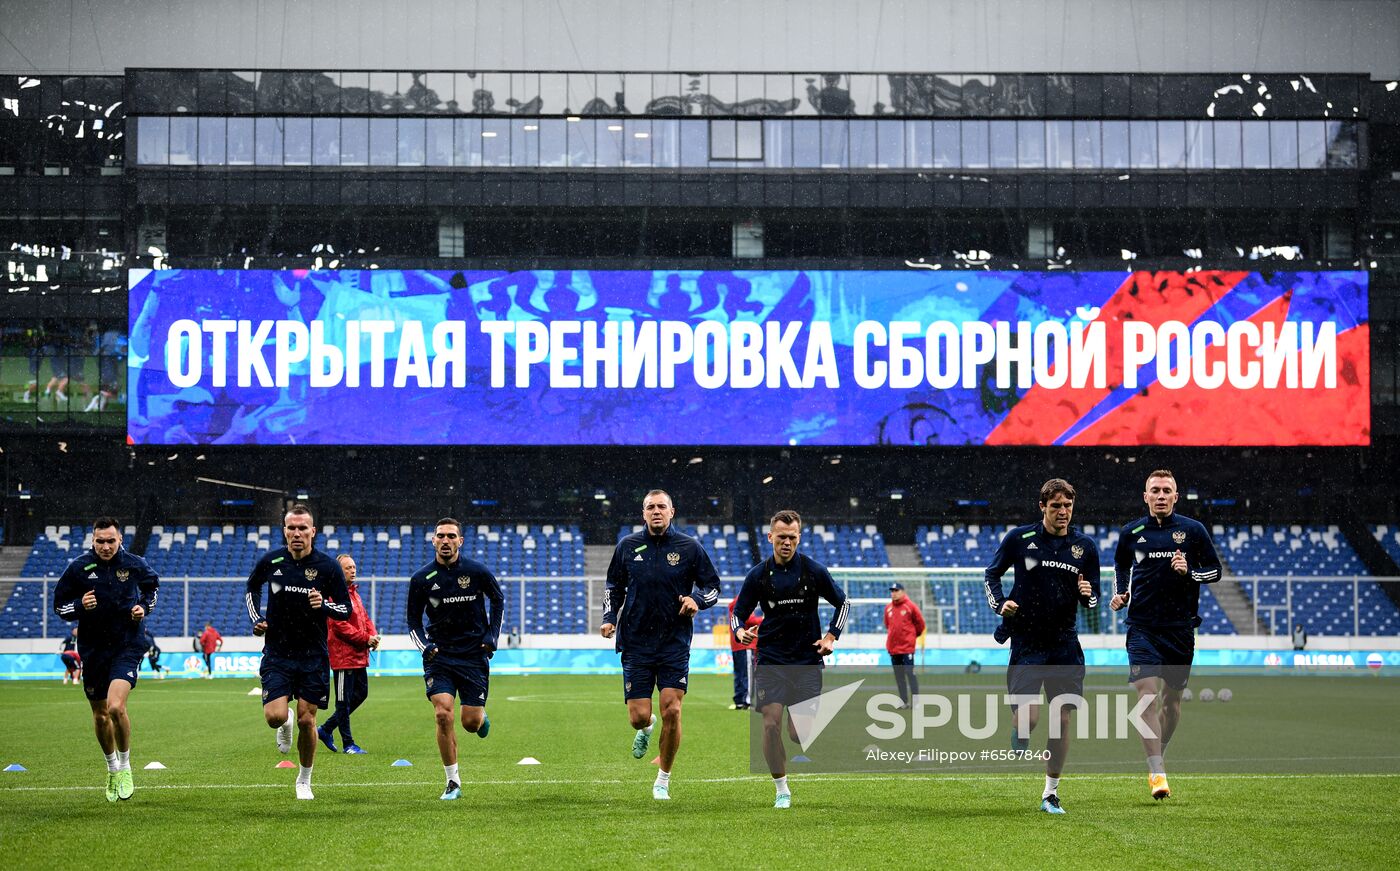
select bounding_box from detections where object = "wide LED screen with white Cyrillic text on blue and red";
[127,269,1371,445]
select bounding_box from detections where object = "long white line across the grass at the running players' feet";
[0,772,1400,793]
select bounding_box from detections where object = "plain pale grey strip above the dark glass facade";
[0,0,1400,78]
